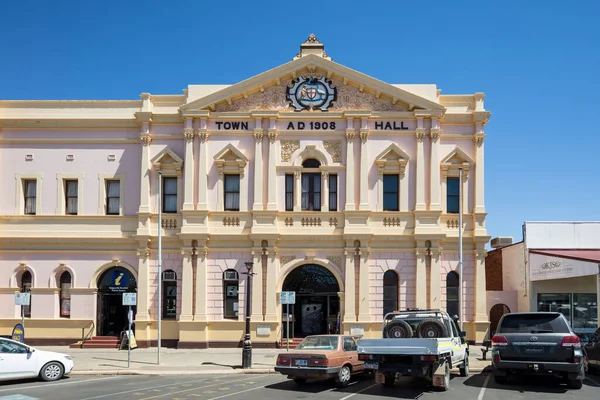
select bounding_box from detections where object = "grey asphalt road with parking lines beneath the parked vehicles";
[0,373,600,400]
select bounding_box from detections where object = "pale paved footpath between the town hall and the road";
[31,346,489,375]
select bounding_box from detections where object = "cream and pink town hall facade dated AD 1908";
[0,35,490,347]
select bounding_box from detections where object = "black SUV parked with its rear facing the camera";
[492,312,585,389]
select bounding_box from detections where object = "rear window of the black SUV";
[496,314,570,333]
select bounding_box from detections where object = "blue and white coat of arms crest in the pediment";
[286,76,337,111]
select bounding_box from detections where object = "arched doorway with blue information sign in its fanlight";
[96,267,137,336]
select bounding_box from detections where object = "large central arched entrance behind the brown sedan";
[282,264,341,337]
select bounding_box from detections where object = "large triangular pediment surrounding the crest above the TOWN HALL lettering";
[181,54,444,115]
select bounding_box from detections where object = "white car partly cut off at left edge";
[0,338,73,381]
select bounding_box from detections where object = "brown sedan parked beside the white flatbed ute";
[275,335,365,387]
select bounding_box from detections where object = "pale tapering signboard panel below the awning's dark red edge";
[529,253,600,281]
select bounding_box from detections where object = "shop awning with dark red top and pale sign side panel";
[529,250,600,281]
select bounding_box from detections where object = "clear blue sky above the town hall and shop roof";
[0,0,600,244]
